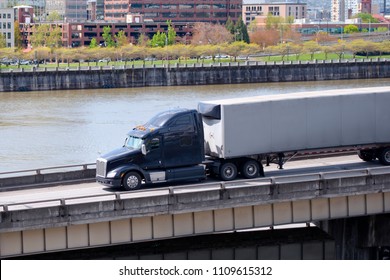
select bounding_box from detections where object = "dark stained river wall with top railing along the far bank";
[0,59,390,92]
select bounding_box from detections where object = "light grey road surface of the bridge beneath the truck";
[0,155,382,206]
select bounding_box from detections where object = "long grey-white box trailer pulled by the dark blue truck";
[198,87,390,179]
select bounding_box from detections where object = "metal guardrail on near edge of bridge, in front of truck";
[0,166,390,212]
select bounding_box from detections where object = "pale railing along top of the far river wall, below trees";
[0,57,390,73]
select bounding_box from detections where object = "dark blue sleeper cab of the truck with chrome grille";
[96,109,206,190]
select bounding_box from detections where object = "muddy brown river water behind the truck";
[0,79,390,172]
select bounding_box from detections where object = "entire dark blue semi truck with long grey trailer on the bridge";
[96,87,390,190]
